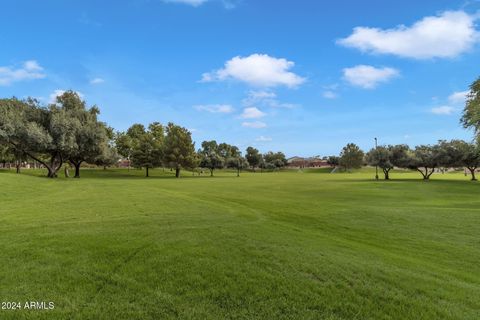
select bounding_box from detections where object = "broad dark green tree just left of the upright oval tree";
[127,122,165,177]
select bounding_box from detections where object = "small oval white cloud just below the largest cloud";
[343,65,399,89]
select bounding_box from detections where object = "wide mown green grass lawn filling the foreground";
[0,170,480,320]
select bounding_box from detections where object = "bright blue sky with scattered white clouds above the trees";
[0,0,480,156]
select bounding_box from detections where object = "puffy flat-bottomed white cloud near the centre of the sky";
[202,54,305,88]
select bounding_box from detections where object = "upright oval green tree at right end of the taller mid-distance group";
[163,122,196,178]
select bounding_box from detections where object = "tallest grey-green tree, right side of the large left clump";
[56,91,112,178]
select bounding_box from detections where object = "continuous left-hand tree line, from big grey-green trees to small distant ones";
[0,91,287,178]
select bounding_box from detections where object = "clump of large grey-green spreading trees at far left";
[0,91,116,178]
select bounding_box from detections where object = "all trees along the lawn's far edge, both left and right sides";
[0,78,480,180]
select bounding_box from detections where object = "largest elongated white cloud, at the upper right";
[337,11,480,59]
